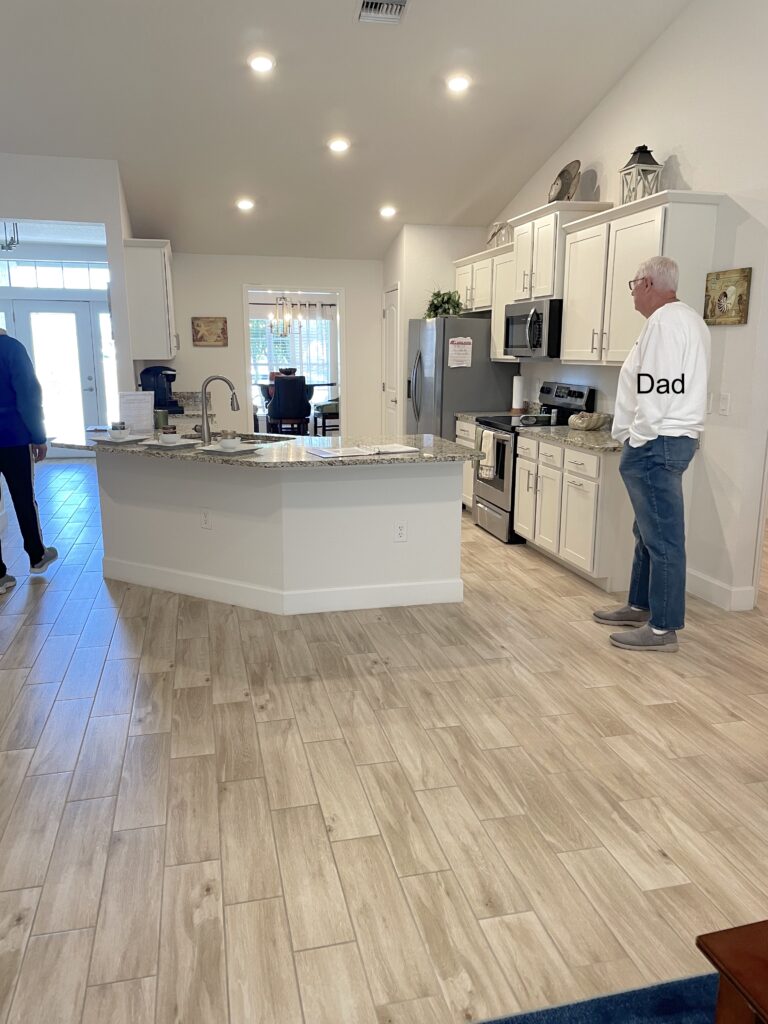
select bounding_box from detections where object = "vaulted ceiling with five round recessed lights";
[0,0,687,258]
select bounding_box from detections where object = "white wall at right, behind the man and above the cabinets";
[495,0,768,605]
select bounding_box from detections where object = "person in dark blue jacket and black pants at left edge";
[0,330,58,594]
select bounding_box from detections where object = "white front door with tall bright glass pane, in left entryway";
[13,300,102,457]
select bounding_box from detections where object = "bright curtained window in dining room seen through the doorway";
[250,302,339,404]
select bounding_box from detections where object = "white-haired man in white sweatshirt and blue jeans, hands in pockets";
[594,256,710,653]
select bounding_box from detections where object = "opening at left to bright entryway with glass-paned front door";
[0,221,119,458]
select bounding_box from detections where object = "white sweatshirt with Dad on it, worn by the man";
[611,301,710,447]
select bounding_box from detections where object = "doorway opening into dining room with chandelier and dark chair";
[246,288,342,434]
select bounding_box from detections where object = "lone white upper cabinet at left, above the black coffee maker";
[124,239,178,359]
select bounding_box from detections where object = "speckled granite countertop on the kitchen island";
[52,434,482,469]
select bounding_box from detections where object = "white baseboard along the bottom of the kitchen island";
[101,558,464,615]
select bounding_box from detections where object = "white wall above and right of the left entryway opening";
[0,153,134,389]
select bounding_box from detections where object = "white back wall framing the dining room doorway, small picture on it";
[171,253,382,435]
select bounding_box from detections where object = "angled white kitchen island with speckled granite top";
[54,434,479,614]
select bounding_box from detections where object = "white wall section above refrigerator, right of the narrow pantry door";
[384,224,487,430]
